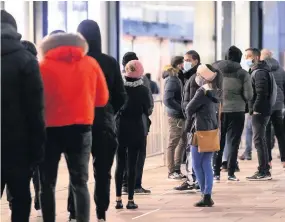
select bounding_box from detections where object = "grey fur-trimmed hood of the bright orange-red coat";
[40,33,88,62]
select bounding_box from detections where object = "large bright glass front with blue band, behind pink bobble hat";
[120,1,195,82]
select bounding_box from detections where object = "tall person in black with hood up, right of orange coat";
[76,20,127,220]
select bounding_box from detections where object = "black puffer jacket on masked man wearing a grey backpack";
[249,61,272,116]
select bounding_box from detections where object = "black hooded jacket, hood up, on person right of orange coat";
[77,20,127,131]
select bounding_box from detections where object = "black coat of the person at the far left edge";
[1,22,45,169]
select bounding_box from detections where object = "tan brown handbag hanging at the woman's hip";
[195,129,220,153]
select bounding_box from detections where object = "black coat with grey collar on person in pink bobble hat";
[118,77,151,146]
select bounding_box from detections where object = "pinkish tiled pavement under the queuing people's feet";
[1,148,285,222]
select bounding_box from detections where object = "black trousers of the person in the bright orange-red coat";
[40,125,92,222]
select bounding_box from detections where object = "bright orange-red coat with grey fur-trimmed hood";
[40,33,109,127]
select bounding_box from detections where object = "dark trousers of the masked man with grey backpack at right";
[252,114,270,174]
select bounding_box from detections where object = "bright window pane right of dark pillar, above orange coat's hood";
[48,1,67,33]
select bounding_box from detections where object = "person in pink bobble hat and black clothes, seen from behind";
[115,60,151,209]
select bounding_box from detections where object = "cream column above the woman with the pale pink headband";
[193,1,216,63]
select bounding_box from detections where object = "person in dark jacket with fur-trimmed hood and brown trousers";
[163,56,187,180]
